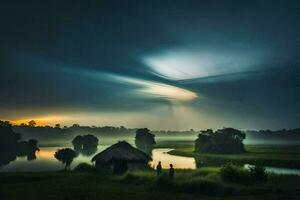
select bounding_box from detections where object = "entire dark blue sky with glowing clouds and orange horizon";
[0,0,300,129]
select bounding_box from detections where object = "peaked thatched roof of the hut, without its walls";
[92,141,152,163]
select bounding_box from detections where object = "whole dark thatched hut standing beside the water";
[92,141,152,173]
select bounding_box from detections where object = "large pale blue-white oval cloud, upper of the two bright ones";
[142,48,266,80]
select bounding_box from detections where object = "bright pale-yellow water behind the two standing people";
[150,148,196,169]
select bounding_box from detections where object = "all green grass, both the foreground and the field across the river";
[0,141,300,200]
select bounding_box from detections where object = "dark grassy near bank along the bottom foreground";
[0,168,300,200]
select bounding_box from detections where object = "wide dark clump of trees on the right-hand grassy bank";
[195,128,245,153]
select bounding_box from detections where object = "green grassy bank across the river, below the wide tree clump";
[168,144,300,168]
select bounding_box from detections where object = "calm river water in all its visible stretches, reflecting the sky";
[0,145,300,175]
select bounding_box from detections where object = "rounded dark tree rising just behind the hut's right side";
[135,128,156,154]
